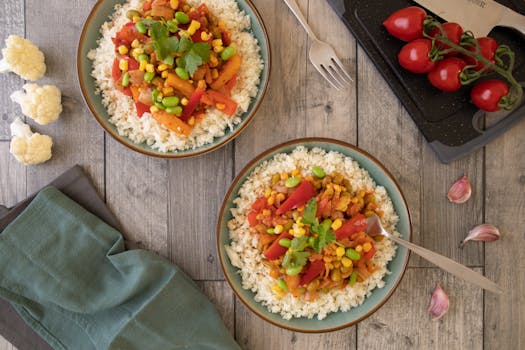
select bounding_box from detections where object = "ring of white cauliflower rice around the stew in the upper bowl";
[88,0,264,152]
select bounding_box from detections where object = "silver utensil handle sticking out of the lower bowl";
[388,234,503,294]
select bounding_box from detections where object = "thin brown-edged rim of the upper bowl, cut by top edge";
[76,0,272,159]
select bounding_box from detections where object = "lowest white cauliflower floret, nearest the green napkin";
[9,118,53,165]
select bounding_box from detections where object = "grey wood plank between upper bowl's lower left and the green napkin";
[106,136,170,257]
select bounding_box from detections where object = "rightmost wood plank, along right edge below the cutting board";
[484,122,525,349]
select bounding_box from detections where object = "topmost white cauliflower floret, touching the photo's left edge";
[0,35,46,81]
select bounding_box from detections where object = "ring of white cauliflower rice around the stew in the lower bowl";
[225,146,399,320]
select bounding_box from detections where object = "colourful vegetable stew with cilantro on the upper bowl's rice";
[112,0,242,136]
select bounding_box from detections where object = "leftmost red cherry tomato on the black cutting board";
[383,6,427,41]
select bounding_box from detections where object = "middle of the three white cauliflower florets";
[11,84,62,125]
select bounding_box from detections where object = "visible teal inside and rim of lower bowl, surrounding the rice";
[217,138,412,333]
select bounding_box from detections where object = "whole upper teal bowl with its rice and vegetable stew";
[77,0,270,158]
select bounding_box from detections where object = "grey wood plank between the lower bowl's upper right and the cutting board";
[357,46,424,265]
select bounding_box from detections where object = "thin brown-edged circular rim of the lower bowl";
[216,137,412,333]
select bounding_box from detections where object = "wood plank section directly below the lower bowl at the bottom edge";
[235,299,356,350]
